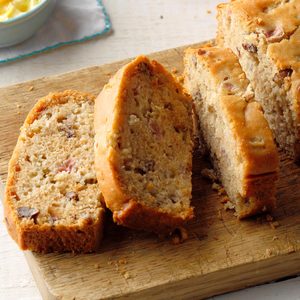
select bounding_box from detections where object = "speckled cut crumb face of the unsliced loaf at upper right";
[218,1,300,157]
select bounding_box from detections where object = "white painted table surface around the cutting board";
[0,0,300,300]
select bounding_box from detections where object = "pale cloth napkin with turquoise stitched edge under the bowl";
[0,0,111,64]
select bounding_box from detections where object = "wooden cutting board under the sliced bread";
[0,42,300,300]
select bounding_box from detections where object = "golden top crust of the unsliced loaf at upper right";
[217,0,300,69]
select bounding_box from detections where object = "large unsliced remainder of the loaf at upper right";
[217,0,300,160]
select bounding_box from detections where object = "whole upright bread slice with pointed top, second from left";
[95,56,193,234]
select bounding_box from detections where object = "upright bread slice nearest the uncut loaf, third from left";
[184,45,278,218]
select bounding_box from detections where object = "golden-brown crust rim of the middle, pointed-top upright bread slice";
[94,56,193,233]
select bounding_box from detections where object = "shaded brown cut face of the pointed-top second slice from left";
[113,62,192,216]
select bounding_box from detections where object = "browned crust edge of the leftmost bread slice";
[4,91,104,253]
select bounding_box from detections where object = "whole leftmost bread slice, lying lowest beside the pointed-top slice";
[4,91,104,252]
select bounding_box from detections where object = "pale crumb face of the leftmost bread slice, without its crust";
[14,96,101,225]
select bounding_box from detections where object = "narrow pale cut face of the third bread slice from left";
[185,49,256,212]
